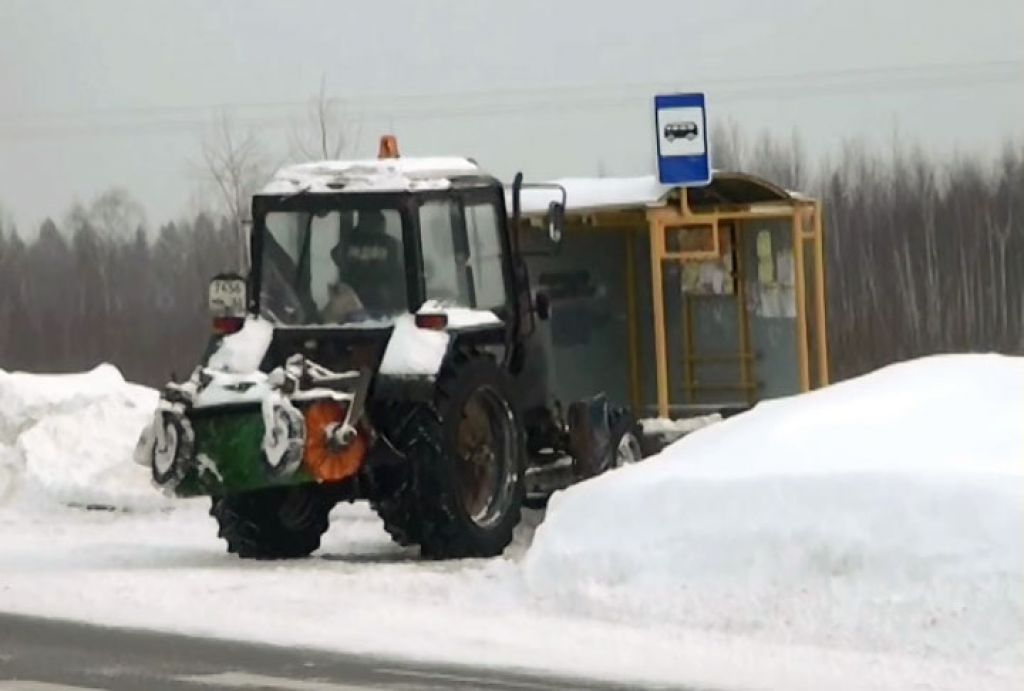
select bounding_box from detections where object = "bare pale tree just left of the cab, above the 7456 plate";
[203,113,268,271]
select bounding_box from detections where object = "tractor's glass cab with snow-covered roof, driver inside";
[251,159,517,327]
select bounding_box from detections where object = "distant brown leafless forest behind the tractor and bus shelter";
[0,127,1024,385]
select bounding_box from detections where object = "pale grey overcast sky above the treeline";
[0,0,1024,232]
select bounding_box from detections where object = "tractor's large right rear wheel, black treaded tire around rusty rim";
[374,353,525,559]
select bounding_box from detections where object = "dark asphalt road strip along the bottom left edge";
[0,613,663,691]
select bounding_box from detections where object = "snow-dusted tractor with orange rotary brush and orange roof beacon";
[136,137,642,559]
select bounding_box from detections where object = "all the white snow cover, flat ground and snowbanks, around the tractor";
[0,355,1024,689]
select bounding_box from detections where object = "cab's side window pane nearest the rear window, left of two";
[420,201,473,307]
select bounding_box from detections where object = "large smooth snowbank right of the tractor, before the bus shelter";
[523,355,1024,670]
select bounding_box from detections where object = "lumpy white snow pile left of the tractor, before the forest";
[0,364,165,509]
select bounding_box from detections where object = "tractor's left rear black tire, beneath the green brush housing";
[210,484,333,559]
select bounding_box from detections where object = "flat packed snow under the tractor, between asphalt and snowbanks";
[0,501,1019,691]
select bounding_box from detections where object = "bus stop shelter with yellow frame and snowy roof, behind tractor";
[520,171,828,418]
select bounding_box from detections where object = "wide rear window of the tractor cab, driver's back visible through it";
[260,209,409,325]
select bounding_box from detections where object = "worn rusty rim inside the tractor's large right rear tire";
[456,388,519,528]
